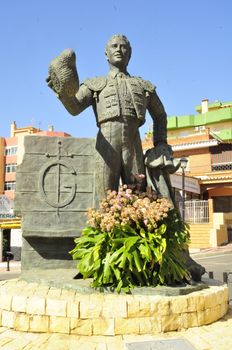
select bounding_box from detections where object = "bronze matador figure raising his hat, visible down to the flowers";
[47,35,171,204]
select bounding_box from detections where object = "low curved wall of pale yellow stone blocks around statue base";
[0,280,228,336]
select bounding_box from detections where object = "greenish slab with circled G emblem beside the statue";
[14,135,96,270]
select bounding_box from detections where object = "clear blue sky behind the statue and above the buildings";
[0,0,232,137]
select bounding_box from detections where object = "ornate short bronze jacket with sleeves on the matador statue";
[57,71,167,144]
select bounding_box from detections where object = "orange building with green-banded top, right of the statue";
[143,100,232,248]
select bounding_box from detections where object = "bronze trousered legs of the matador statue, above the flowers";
[96,118,145,200]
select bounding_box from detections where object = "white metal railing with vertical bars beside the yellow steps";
[179,200,209,224]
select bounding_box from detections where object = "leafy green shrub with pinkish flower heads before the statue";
[70,185,189,292]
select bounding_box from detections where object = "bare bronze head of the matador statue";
[105,34,132,69]
